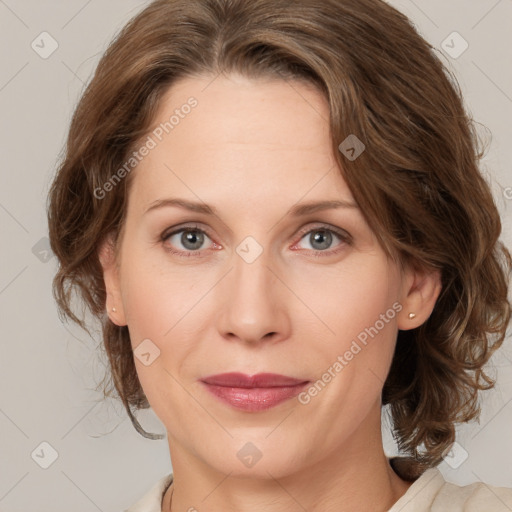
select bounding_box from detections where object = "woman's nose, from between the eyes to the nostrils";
[217,246,291,344]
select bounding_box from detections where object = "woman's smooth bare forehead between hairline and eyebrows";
[126,75,351,212]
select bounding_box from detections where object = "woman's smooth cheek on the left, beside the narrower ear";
[122,257,200,418]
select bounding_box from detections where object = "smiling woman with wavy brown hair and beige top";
[48,0,512,512]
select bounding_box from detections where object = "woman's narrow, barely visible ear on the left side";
[98,234,127,326]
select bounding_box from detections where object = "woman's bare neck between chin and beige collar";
[162,411,411,512]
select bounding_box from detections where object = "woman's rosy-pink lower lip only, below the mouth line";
[203,382,309,412]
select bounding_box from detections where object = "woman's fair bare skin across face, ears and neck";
[100,75,441,512]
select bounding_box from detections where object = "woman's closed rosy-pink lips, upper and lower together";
[201,373,310,412]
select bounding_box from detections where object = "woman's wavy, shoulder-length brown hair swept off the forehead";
[48,0,512,473]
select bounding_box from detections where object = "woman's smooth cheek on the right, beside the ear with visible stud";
[292,254,401,408]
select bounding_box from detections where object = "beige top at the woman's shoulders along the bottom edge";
[124,468,512,512]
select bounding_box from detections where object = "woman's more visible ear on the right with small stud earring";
[398,266,442,331]
